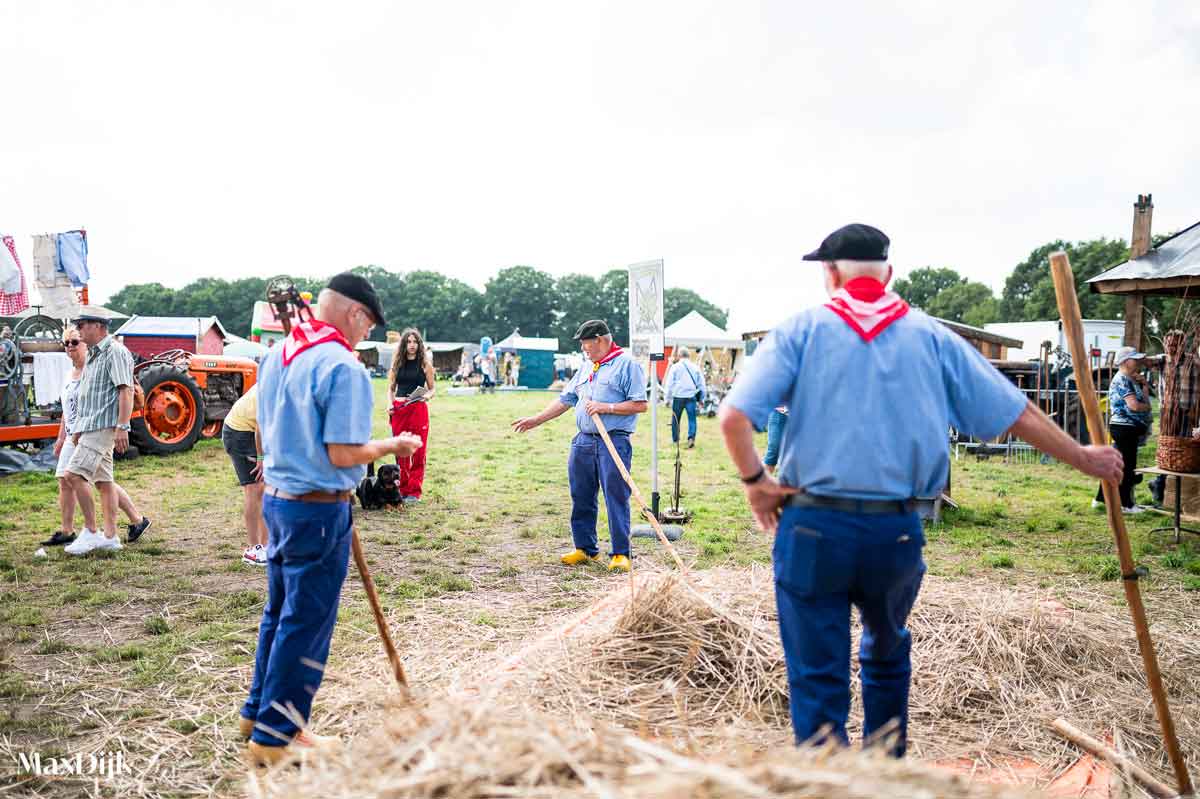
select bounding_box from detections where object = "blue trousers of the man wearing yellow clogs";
[566,433,634,555]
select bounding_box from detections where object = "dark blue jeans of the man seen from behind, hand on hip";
[774,507,925,757]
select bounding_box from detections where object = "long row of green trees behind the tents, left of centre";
[106,265,728,350]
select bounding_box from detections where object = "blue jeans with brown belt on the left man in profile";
[241,494,352,746]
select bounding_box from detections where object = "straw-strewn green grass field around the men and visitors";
[0,383,1200,795]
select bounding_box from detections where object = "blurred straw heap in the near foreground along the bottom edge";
[260,699,1032,799]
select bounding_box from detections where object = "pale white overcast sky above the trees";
[0,0,1200,331]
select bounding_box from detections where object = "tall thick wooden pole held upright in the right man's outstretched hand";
[1050,252,1192,797]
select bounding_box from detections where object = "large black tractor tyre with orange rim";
[131,364,204,455]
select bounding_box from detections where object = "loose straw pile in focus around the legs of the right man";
[526,569,1200,775]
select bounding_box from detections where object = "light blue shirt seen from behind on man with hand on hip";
[725,306,1027,499]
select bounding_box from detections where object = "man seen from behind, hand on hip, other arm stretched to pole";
[720,224,1121,757]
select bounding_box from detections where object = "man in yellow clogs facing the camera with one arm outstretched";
[512,319,647,571]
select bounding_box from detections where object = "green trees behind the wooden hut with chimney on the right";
[894,234,1178,340]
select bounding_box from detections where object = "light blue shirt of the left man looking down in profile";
[258,342,374,495]
